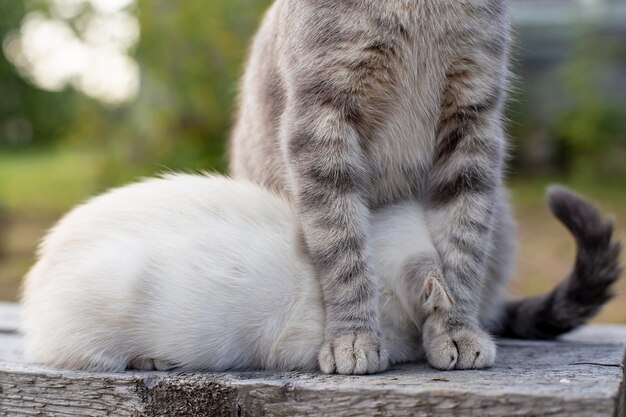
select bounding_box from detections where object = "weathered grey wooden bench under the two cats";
[0,304,626,417]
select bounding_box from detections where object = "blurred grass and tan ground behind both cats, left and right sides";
[0,150,626,324]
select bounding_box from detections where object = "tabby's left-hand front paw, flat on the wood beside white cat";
[319,332,389,375]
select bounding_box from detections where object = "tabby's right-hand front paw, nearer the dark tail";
[424,318,496,371]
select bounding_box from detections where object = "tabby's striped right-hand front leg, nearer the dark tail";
[425,44,506,369]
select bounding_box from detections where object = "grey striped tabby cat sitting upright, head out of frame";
[231,0,619,374]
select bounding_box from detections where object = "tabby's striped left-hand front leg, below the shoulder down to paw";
[289,109,388,374]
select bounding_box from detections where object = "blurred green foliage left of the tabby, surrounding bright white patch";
[0,0,271,185]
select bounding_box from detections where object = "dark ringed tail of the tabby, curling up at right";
[499,186,622,339]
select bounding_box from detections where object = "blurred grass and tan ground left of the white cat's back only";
[0,150,103,301]
